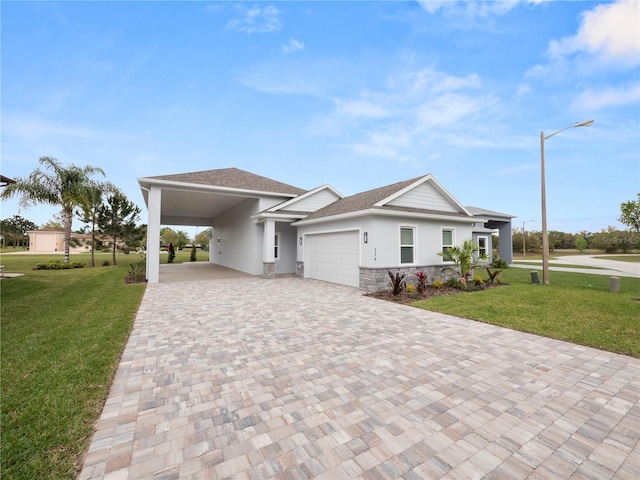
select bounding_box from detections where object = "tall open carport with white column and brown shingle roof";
[138,168,304,283]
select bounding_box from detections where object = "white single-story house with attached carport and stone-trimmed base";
[138,168,513,291]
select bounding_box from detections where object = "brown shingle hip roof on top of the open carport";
[146,168,306,195]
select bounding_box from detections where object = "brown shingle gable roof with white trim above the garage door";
[297,174,471,224]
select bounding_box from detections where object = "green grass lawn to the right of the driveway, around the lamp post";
[410,268,640,357]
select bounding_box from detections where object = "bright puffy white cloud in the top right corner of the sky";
[549,0,640,66]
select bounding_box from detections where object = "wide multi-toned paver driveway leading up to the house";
[80,278,640,480]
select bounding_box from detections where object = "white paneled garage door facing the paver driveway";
[304,231,360,287]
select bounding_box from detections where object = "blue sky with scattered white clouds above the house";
[0,1,640,237]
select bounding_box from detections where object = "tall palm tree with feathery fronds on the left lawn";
[0,157,104,263]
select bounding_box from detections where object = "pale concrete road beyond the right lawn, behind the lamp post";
[513,255,640,278]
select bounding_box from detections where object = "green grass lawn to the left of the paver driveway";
[0,254,145,479]
